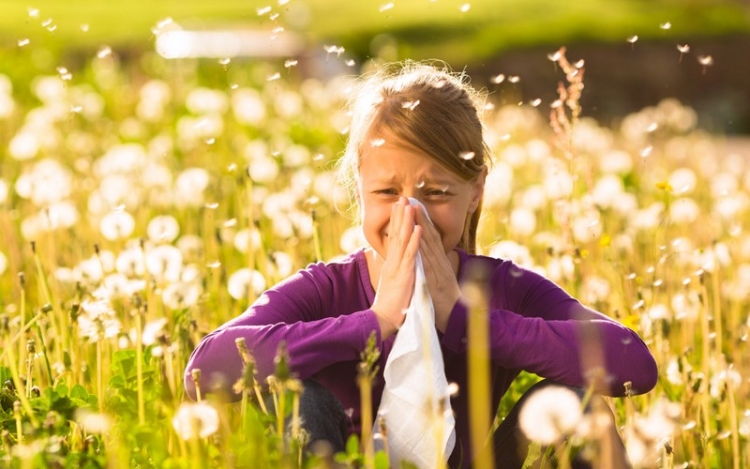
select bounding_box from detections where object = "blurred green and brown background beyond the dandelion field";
[0,0,750,133]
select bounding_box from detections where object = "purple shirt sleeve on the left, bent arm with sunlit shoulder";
[184,265,380,398]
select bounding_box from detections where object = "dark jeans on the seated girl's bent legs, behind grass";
[284,379,630,469]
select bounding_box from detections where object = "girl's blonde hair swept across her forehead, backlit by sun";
[338,61,489,253]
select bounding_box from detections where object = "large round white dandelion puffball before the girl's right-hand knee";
[518,386,583,445]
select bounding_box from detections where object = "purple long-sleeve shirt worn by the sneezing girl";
[185,250,657,465]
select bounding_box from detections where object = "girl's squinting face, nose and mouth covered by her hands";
[359,133,484,258]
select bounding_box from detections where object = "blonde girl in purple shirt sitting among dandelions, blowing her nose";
[185,63,657,467]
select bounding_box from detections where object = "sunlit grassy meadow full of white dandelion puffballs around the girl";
[0,0,750,469]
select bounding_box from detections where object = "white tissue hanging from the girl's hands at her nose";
[373,198,456,469]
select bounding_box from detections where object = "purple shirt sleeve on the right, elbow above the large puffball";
[443,261,657,396]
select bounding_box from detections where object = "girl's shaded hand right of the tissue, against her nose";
[416,209,461,332]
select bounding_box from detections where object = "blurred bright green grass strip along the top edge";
[0,0,750,61]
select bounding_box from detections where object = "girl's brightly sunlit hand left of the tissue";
[371,197,422,340]
